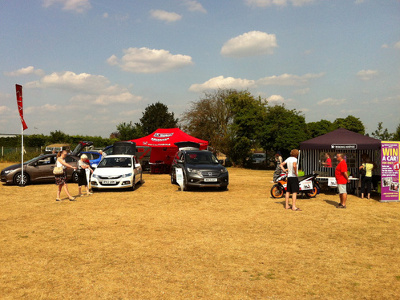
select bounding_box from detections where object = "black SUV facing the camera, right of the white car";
[171,150,229,191]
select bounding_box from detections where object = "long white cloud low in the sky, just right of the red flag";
[25,71,142,105]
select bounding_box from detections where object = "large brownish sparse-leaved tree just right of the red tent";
[181,89,237,154]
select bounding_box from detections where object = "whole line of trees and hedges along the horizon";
[0,89,400,165]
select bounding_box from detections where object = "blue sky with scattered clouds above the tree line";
[0,0,400,137]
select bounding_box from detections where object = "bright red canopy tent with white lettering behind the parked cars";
[131,128,208,172]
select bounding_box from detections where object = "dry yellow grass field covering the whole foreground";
[0,164,400,299]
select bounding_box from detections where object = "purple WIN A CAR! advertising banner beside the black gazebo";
[381,142,400,202]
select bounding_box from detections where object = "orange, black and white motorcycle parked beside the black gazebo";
[271,173,321,198]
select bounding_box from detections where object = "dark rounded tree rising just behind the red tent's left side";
[140,102,178,135]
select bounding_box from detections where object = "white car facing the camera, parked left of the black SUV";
[90,155,143,190]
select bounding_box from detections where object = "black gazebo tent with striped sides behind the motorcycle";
[300,128,381,177]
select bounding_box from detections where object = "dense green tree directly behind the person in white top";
[261,104,308,156]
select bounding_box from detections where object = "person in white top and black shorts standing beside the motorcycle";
[280,149,301,211]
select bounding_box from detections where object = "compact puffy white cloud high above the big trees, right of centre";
[221,31,278,57]
